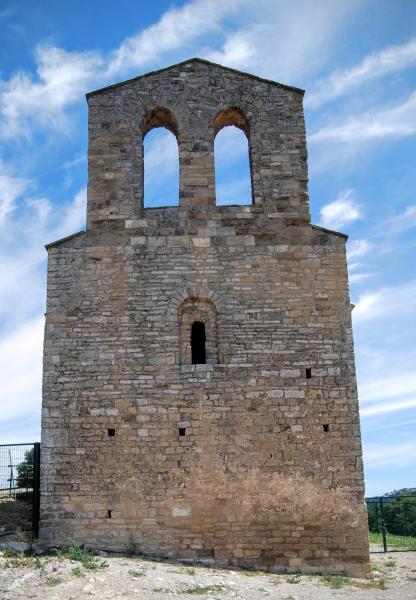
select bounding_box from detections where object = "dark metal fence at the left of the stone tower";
[0,443,40,538]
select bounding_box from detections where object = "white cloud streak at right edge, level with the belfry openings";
[309,92,416,148]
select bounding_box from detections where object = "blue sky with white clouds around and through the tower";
[0,0,416,495]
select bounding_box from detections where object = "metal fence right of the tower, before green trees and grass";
[366,490,416,552]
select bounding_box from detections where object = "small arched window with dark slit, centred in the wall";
[179,298,218,365]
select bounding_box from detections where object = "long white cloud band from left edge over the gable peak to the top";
[0,0,360,138]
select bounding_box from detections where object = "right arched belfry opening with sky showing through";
[213,108,253,205]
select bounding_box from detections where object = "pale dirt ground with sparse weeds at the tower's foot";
[0,552,416,600]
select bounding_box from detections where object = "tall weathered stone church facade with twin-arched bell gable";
[41,59,369,575]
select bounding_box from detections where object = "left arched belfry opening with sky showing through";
[143,107,179,208]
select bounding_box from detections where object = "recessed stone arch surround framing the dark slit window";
[178,296,218,365]
